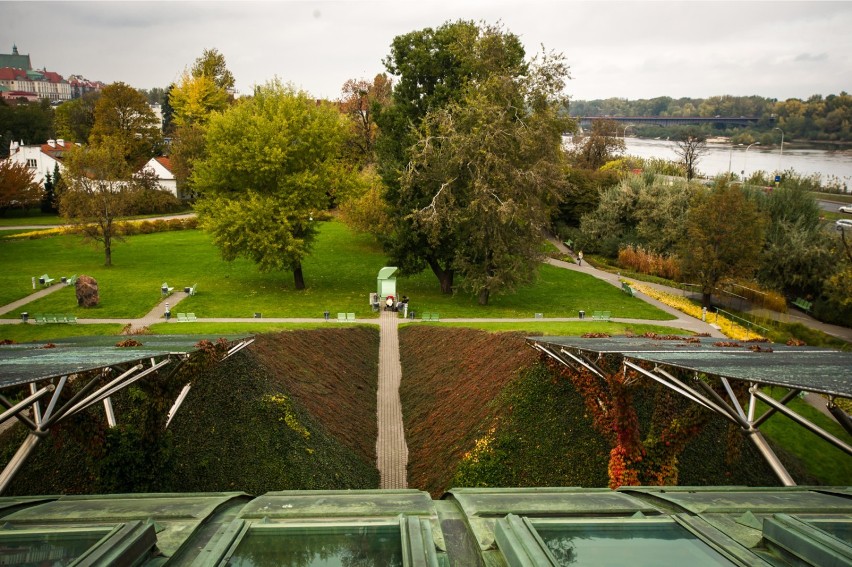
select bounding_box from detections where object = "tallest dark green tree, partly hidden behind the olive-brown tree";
[376,21,527,293]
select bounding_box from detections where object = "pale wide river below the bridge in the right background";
[568,137,852,191]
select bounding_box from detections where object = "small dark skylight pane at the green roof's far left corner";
[0,531,107,567]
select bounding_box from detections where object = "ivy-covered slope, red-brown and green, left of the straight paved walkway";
[3,328,379,495]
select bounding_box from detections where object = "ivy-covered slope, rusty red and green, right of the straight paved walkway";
[400,326,792,496]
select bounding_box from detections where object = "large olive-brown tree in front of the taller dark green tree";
[401,54,567,305]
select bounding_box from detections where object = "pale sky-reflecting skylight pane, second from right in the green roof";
[534,522,731,567]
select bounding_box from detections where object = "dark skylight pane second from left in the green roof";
[228,525,402,567]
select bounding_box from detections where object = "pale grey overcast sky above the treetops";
[0,0,852,100]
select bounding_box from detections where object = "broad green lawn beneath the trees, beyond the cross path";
[0,222,672,320]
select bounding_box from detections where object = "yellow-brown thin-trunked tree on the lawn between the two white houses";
[59,138,134,266]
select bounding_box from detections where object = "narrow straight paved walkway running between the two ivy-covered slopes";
[376,311,408,488]
